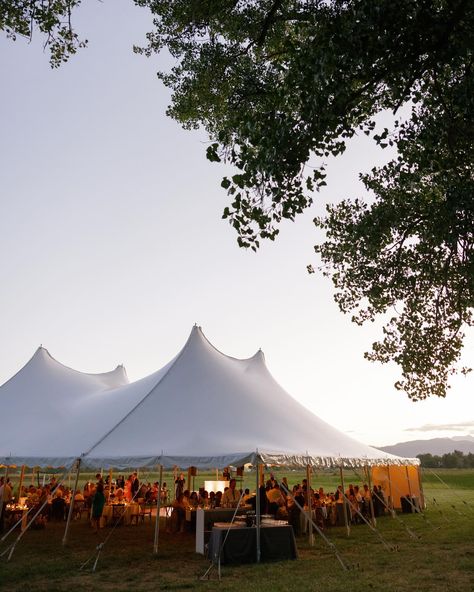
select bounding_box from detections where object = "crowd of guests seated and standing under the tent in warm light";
[0,471,387,533]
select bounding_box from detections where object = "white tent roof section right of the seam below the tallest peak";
[85,326,417,468]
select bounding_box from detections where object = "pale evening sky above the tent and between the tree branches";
[0,0,474,445]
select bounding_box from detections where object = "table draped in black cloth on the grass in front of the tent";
[209,525,298,563]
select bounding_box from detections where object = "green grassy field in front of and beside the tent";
[0,470,474,592]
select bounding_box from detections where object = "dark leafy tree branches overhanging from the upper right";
[0,0,474,400]
